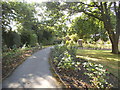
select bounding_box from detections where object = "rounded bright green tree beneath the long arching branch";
[69,13,108,41]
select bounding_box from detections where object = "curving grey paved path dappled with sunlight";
[2,47,60,88]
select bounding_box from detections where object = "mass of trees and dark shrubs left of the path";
[1,1,54,48]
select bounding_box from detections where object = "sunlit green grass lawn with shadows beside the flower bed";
[77,49,120,79]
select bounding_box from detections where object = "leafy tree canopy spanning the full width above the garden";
[2,1,120,53]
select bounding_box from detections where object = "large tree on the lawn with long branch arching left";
[45,1,120,54]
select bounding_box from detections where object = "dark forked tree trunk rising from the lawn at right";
[100,2,120,54]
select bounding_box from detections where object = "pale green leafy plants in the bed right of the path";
[51,41,115,88]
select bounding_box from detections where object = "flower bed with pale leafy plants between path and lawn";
[51,44,118,88]
